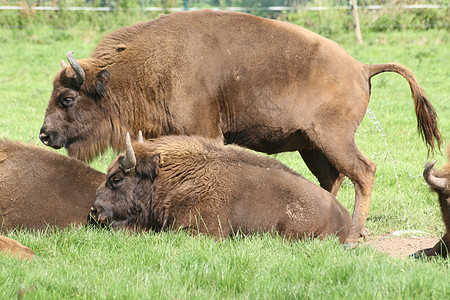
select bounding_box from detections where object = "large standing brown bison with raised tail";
[40,10,441,240]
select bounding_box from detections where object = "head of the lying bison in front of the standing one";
[91,134,159,229]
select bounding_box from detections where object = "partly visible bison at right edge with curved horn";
[414,144,450,258]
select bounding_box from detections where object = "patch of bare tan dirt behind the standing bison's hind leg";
[363,234,439,258]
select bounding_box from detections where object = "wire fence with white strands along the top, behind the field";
[0,0,450,12]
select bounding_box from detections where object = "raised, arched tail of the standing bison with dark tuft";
[367,63,442,154]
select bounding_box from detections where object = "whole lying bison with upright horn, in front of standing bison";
[92,135,350,242]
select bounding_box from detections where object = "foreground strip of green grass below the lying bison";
[0,228,449,299]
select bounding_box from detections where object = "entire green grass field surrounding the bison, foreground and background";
[0,18,450,299]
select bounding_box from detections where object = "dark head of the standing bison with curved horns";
[39,51,112,160]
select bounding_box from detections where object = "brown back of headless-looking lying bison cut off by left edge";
[0,140,105,231]
